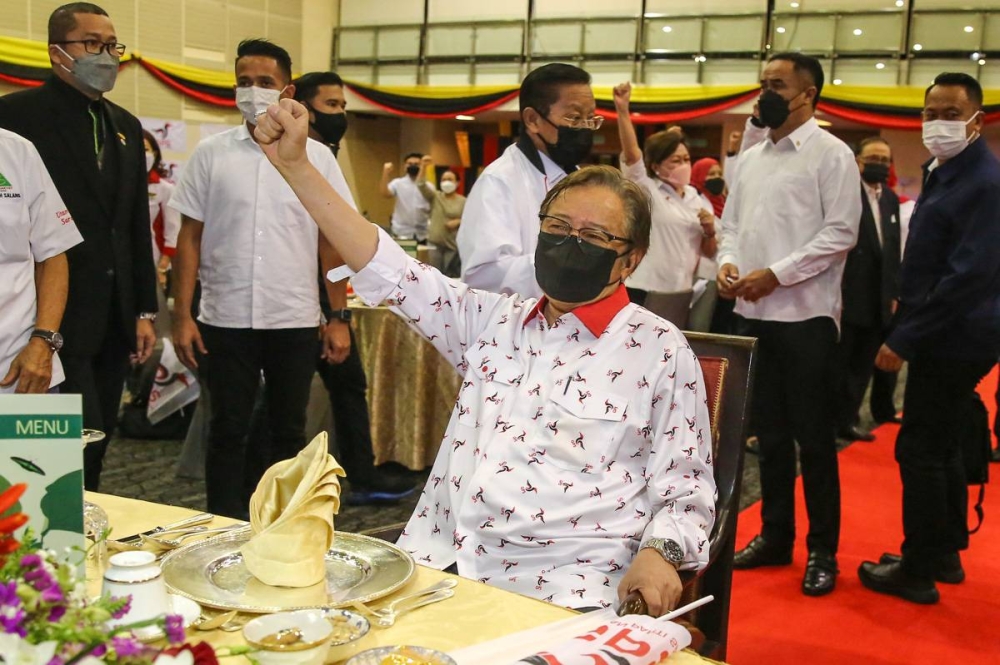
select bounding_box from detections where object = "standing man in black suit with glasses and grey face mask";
[0,2,157,490]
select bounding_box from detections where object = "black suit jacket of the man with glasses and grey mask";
[0,76,157,356]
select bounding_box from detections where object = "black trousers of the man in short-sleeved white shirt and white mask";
[198,323,319,519]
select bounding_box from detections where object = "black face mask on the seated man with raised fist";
[535,231,628,303]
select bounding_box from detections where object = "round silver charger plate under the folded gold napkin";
[160,528,413,614]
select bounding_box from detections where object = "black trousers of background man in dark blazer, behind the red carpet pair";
[835,323,883,429]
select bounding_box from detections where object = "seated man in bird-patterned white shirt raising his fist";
[257,100,715,615]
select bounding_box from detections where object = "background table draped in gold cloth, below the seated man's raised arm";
[351,306,462,470]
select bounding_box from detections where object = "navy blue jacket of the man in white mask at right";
[886,138,1000,362]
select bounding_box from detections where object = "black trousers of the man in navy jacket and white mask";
[896,355,996,577]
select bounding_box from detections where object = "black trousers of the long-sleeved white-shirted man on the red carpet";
[738,317,840,554]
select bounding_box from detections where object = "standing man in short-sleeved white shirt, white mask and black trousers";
[170,39,353,518]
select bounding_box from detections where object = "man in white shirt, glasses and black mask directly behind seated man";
[458,63,604,298]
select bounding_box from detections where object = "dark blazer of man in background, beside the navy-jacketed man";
[841,184,900,326]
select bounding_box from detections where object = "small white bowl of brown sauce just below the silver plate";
[243,610,333,665]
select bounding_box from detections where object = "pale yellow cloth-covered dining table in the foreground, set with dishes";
[87,492,714,665]
